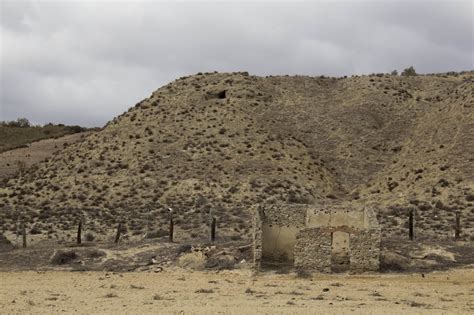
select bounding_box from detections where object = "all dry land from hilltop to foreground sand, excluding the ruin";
[0,71,474,314]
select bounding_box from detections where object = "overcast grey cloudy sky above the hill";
[0,0,474,127]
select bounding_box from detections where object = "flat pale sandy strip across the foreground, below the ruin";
[0,268,474,314]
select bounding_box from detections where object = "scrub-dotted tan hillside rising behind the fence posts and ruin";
[0,72,474,238]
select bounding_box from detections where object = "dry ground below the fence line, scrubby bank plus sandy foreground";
[0,238,474,314]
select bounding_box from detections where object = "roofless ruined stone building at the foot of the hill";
[253,204,380,272]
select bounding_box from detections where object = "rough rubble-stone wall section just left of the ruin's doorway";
[295,228,332,272]
